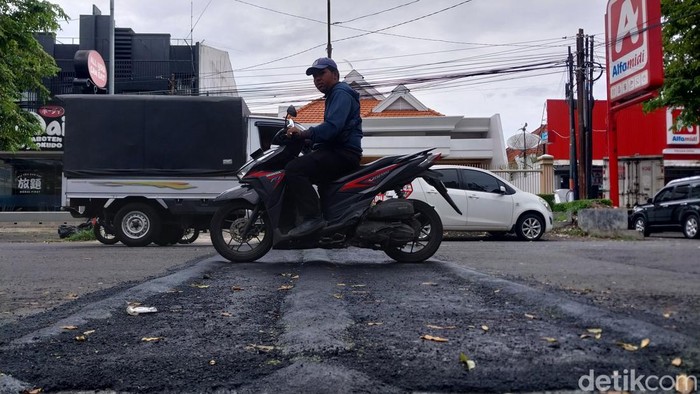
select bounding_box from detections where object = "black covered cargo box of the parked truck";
[58,95,250,178]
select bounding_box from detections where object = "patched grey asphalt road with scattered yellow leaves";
[0,232,700,392]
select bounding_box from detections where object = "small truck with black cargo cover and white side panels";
[58,95,284,246]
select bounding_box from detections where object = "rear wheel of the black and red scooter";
[384,200,442,263]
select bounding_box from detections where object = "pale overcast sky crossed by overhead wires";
[52,0,607,139]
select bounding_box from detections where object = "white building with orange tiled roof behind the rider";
[296,70,508,168]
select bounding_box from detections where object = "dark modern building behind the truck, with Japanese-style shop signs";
[0,6,238,211]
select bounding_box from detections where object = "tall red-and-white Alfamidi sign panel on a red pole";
[605,0,664,103]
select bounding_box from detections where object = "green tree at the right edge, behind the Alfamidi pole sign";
[644,0,700,128]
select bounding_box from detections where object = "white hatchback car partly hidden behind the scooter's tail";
[406,165,554,241]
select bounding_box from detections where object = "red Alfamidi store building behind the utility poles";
[546,100,700,207]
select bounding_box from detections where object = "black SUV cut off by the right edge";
[630,176,700,238]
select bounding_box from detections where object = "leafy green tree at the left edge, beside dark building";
[0,0,68,151]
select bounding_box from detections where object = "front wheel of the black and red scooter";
[209,201,272,263]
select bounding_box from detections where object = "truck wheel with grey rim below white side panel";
[114,203,161,246]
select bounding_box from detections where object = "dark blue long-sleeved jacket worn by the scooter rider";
[309,82,362,155]
